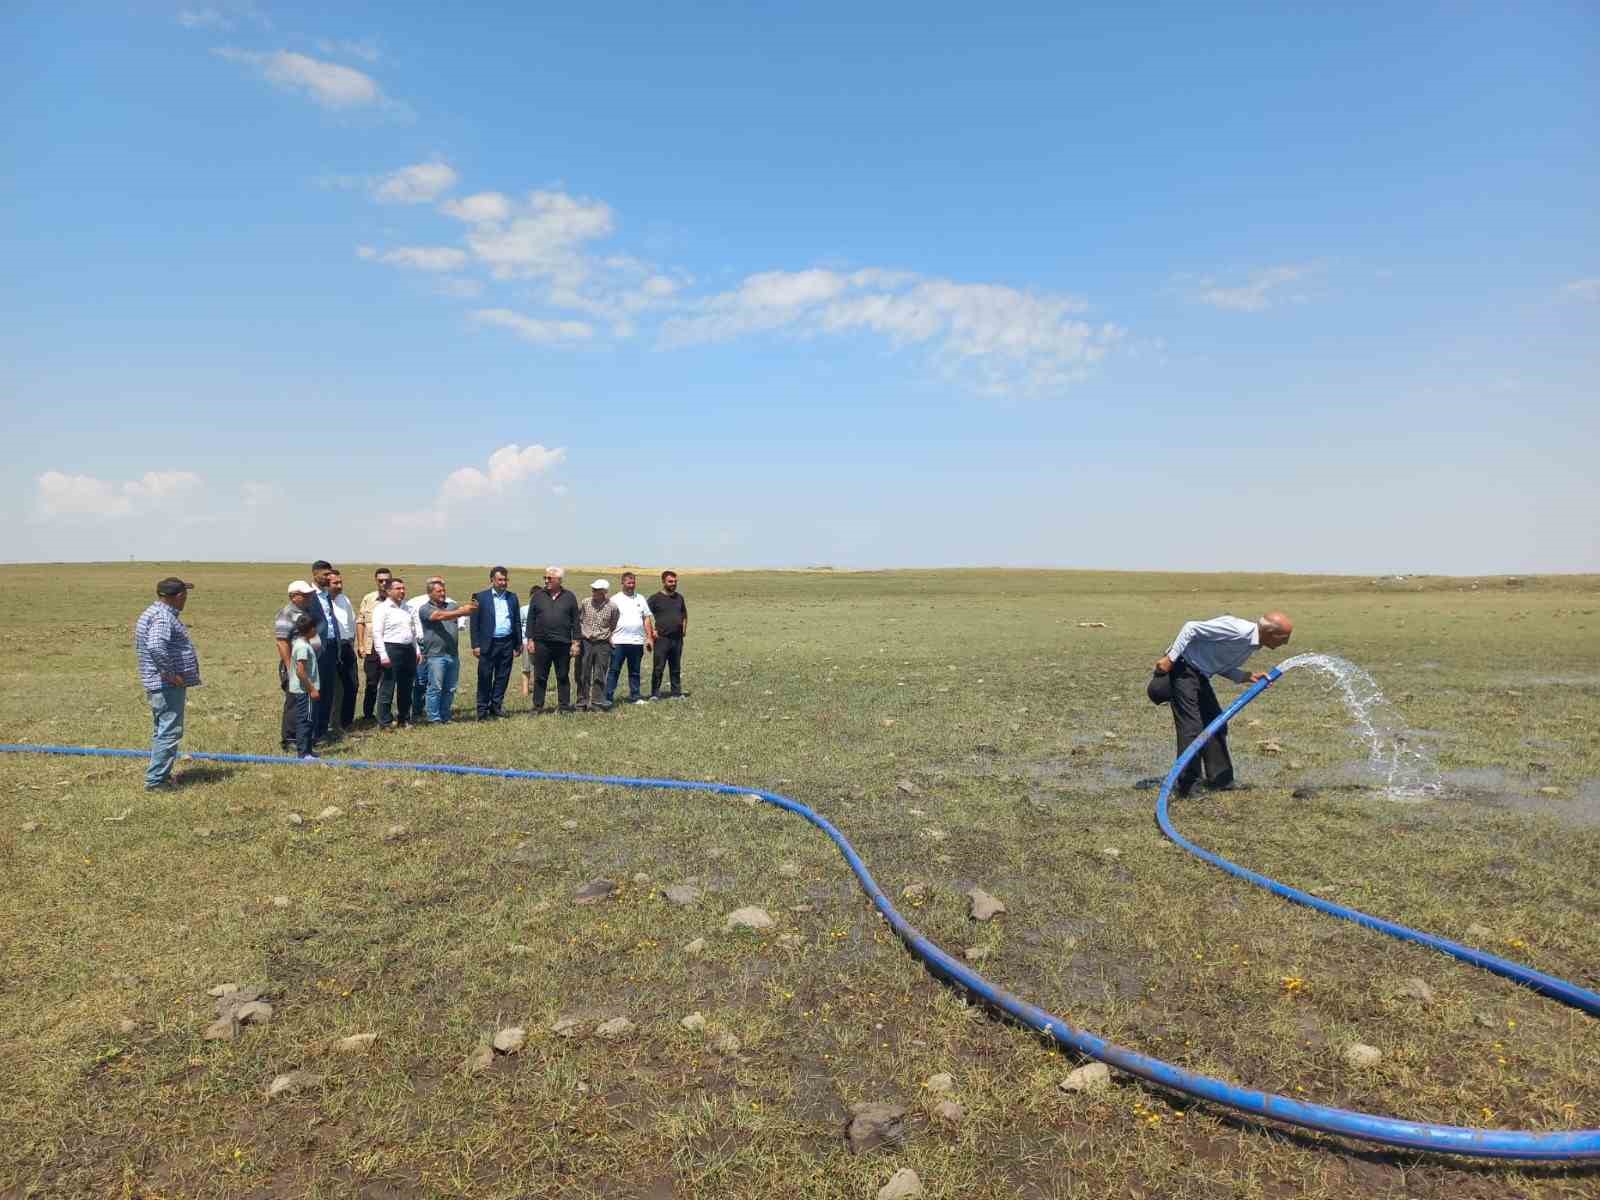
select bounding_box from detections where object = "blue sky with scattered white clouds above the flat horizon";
[0,0,1600,573]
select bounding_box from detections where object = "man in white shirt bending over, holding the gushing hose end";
[1146,613,1294,797]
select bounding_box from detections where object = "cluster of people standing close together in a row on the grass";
[274,560,688,757]
